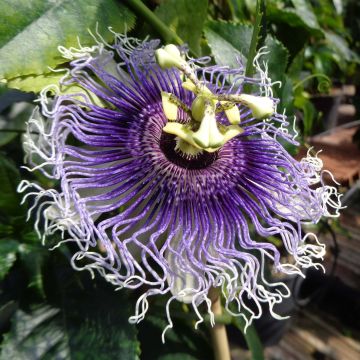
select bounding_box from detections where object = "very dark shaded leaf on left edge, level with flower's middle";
[0,154,23,215]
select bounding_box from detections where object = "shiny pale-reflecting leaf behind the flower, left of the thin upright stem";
[204,21,252,68]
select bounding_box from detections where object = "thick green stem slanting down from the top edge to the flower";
[125,0,184,45]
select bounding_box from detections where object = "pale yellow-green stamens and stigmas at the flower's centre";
[155,44,275,155]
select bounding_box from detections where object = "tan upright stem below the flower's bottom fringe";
[209,288,231,360]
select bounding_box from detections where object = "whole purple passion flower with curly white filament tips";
[19,34,340,336]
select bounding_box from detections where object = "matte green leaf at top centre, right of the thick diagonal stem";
[155,0,208,54]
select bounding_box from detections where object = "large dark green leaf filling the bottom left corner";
[0,299,138,360]
